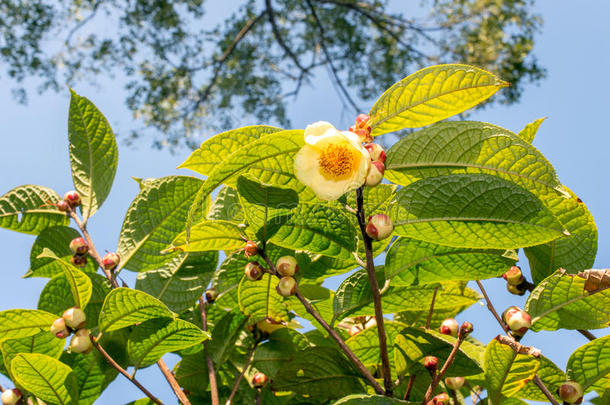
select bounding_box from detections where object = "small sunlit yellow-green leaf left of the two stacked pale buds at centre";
[238,273,289,324]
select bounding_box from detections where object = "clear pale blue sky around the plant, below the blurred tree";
[0,0,610,404]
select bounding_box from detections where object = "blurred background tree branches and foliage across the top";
[0,0,545,146]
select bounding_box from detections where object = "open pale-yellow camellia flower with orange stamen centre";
[294,121,371,201]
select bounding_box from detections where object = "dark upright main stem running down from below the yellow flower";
[356,187,394,397]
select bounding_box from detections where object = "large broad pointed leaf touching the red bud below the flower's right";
[391,174,568,249]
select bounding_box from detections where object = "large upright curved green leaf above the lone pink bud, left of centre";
[118,176,203,271]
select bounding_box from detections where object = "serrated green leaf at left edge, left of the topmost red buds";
[0,185,70,235]
